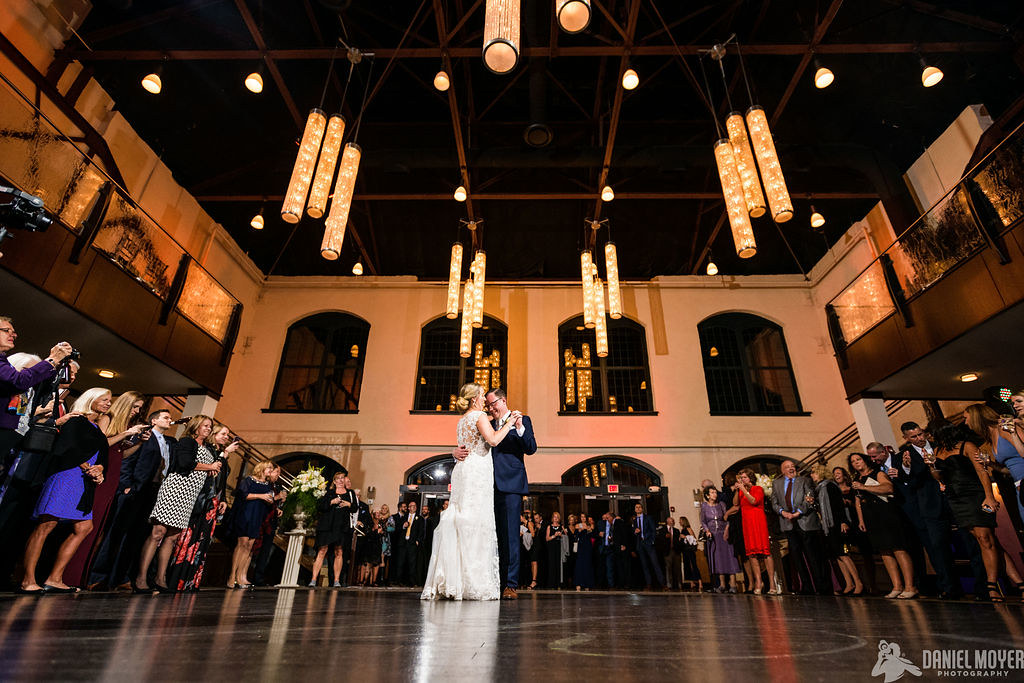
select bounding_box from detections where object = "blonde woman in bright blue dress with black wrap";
[18,387,112,593]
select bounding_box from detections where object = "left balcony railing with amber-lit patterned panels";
[0,74,241,346]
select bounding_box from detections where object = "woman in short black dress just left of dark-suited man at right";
[847,453,918,600]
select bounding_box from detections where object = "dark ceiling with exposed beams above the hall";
[66,0,1024,280]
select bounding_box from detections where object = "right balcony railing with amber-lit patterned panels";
[825,124,1024,352]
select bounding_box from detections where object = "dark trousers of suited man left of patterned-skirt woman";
[89,483,160,588]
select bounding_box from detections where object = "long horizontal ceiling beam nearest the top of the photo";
[60,40,1014,61]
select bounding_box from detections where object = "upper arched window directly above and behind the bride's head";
[413,315,508,413]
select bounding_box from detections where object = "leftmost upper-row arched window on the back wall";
[270,313,370,413]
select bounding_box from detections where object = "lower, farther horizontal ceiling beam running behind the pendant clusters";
[195,191,879,202]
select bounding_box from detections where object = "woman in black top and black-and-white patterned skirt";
[132,414,221,593]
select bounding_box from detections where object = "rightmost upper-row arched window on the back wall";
[697,313,803,415]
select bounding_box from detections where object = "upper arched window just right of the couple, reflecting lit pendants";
[558,315,654,415]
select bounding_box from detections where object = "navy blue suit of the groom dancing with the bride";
[490,416,537,589]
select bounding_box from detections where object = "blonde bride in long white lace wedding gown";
[420,384,517,600]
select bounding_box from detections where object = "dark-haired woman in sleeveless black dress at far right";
[929,421,1024,602]
